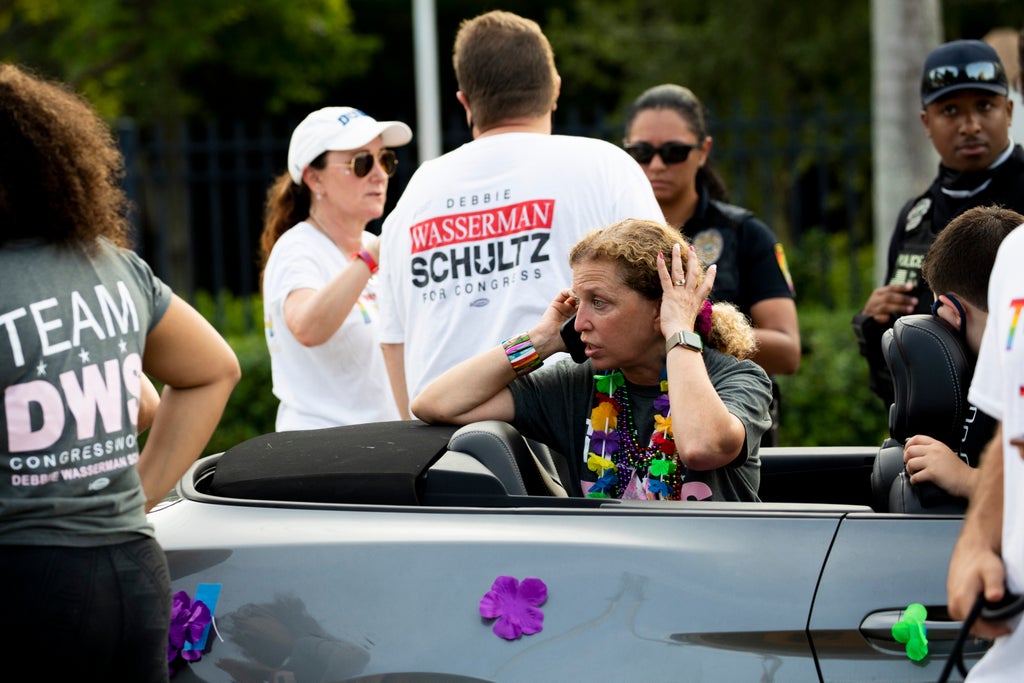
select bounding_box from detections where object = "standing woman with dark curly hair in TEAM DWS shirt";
[0,65,240,681]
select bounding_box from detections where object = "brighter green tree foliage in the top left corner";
[0,0,381,124]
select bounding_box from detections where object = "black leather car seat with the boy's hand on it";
[871,313,975,513]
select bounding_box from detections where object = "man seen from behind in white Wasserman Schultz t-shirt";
[378,11,665,417]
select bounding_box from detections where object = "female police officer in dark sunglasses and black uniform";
[624,84,801,445]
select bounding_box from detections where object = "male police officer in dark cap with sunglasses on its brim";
[853,40,1024,408]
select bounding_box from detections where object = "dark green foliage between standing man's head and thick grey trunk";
[546,0,870,117]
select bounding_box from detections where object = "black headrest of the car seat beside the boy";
[882,313,974,452]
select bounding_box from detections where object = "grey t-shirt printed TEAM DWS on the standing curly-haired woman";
[0,241,171,547]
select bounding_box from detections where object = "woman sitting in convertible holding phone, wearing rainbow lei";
[412,219,771,501]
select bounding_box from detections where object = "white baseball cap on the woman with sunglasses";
[288,106,413,184]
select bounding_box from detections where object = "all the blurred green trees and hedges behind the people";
[0,0,1024,453]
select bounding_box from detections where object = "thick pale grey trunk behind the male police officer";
[871,0,942,285]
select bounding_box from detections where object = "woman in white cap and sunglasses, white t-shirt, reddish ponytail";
[260,106,413,431]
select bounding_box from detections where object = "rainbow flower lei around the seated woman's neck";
[584,370,684,501]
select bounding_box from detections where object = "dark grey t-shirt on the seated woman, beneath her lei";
[509,348,771,501]
